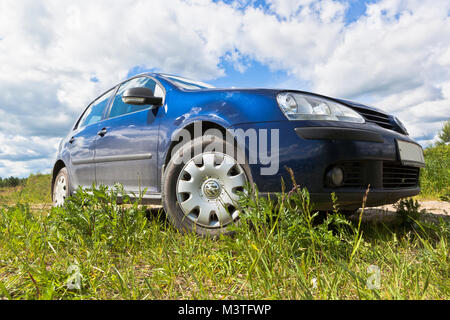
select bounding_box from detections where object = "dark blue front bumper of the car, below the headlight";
[230,121,420,210]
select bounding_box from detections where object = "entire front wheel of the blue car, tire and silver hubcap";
[163,136,252,236]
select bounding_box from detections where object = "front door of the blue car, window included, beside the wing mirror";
[95,76,164,194]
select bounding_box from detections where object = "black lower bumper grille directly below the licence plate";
[383,162,420,189]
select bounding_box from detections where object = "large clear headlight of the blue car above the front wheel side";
[277,92,366,123]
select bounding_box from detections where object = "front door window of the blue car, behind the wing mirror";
[109,77,164,118]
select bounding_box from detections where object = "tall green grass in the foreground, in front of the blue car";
[0,182,450,299]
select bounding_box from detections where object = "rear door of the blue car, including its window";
[68,90,114,188]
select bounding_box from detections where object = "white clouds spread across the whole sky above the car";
[0,0,450,176]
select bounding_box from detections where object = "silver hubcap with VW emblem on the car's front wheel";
[177,153,248,228]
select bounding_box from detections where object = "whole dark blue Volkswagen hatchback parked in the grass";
[52,73,424,236]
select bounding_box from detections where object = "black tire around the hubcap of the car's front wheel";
[162,135,253,237]
